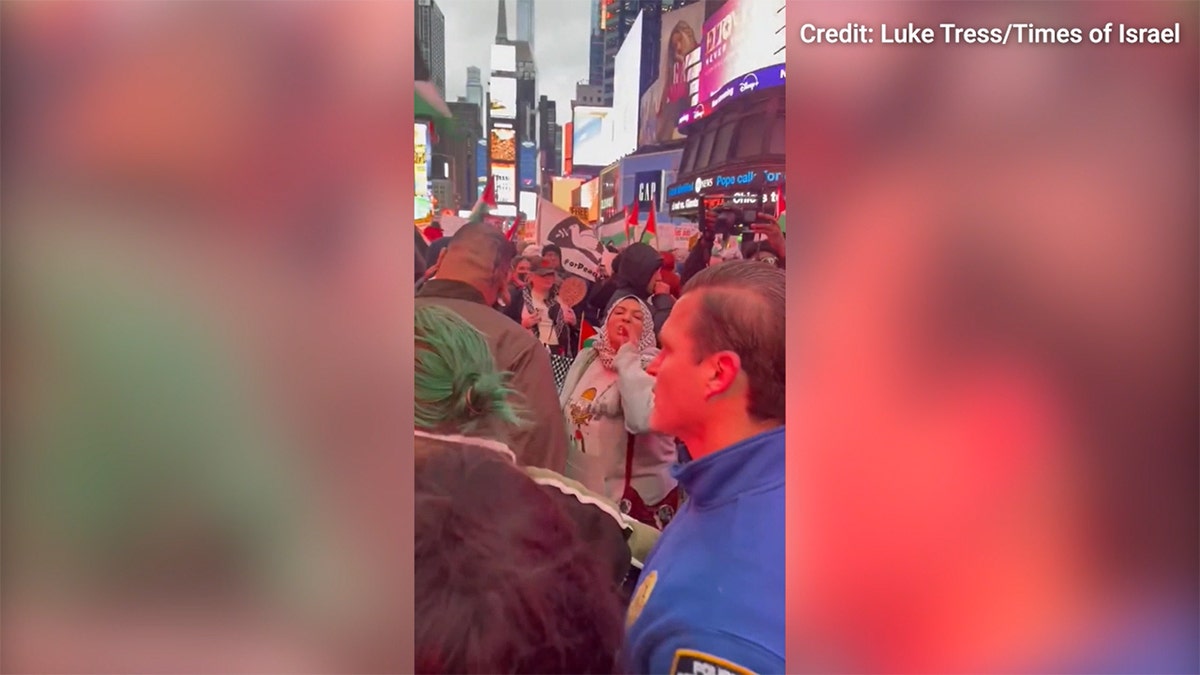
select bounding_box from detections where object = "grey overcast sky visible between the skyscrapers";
[436,0,592,124]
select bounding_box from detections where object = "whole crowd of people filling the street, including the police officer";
[414,215,786,673]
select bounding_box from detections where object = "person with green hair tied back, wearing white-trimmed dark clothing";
[413,305,658,583]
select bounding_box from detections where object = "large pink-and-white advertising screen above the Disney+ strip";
[700,0,787,104]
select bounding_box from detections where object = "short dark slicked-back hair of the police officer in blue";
[680,261,787,422]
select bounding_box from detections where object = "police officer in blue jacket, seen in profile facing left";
[624,261,786,675]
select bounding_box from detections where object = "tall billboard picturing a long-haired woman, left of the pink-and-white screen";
[638,0,705,145]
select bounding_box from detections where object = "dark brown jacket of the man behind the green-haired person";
[416,279,568,473]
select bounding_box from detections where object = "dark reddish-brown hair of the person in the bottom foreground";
[414,437,624,674]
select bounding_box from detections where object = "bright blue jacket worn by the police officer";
[624,426,786,675]
